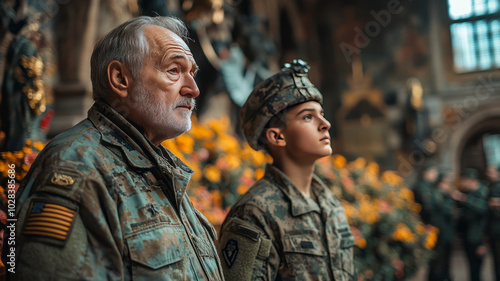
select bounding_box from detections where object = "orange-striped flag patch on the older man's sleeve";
[23,201,76,243]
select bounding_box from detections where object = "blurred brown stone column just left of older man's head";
[49,0,99,137]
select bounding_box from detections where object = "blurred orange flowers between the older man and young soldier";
[162,117,271,226]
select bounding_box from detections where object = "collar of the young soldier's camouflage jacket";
[265,164,327,216]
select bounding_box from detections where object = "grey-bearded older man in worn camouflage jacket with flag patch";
[10,17,223,280]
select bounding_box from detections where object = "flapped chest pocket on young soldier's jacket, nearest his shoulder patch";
[283,233,329,280]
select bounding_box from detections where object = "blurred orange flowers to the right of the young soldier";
[316,155,438,281]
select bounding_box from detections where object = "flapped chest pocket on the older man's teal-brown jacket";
[127,224,189,280]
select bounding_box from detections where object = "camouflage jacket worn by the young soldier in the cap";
[218,165,355,281]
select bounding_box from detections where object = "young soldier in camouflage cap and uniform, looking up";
[219,60,354,281]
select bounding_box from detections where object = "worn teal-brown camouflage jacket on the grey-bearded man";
[10,101,223,281]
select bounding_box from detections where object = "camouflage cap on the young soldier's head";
[240,59,323,150]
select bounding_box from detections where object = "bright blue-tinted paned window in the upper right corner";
[448,0,500,73]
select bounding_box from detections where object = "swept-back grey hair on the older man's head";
[90,16,190,100]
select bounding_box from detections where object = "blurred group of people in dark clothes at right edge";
[414,164,500,281]
